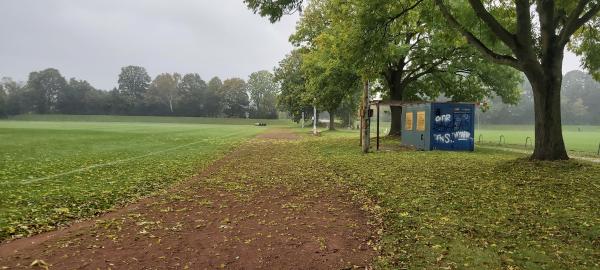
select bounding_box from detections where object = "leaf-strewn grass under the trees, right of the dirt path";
[310,132,600,269]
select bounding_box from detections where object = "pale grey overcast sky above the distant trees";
[0,0,579,89]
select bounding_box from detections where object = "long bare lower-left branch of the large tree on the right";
[435,0,522,70]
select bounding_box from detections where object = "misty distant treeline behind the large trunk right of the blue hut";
[480,70,600,125]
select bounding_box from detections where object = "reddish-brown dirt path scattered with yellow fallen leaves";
[0,130,375,269]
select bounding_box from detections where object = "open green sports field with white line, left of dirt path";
[0,116,264,240]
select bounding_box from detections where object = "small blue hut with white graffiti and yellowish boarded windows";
[402,103,475,151]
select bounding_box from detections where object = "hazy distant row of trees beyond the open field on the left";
[0,66,279,119]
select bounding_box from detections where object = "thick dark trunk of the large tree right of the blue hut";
[527,61,569,160]
